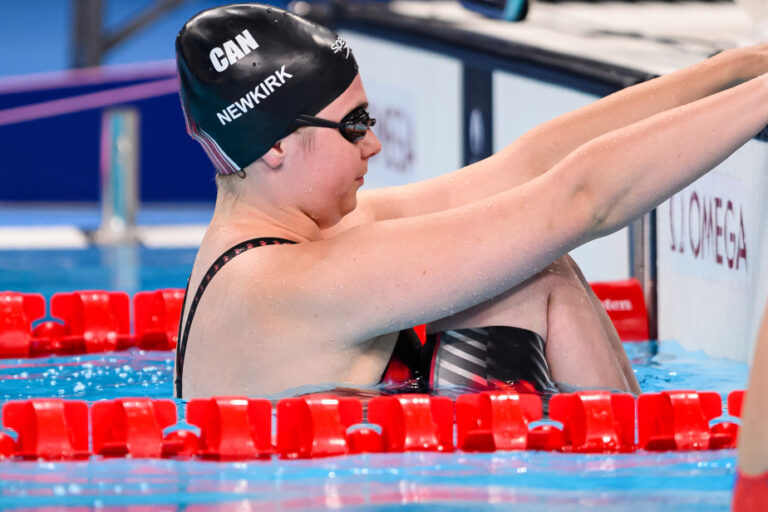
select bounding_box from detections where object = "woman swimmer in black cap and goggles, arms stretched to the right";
[176,4,768,398]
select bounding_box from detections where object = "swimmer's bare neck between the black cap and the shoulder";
[209,188,330,242]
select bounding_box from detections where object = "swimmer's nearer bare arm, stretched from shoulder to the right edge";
[280,71,768,339]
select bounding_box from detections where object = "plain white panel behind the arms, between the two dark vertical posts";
[493,71,630,281]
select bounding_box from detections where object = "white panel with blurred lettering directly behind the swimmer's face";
[341,31,463,188]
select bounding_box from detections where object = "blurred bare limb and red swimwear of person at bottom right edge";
[733,304,768,512]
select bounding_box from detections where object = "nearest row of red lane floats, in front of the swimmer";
[0,391,744,461]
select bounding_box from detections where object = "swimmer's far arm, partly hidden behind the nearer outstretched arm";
[344,44,768,226]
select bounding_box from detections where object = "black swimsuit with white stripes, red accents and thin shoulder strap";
[175,238,556,398]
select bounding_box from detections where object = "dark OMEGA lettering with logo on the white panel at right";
[668,177,750,275]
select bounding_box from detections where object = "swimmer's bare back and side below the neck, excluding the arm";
[177,230,397,398]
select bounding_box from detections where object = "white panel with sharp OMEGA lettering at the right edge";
[657,140,768,361]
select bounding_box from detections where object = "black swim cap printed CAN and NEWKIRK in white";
[176,4,357,174]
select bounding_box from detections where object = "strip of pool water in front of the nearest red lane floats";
[0,452,733,512]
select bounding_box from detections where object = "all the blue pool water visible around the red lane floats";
[0,247,747,512]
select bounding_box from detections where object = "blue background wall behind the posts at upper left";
[0,0,288,202]
